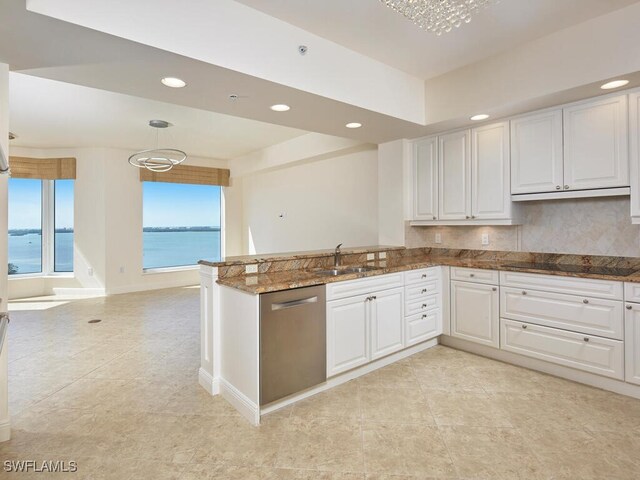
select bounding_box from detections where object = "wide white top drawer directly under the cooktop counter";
[500,272,622,300]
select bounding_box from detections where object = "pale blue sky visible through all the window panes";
[9,178,220,230]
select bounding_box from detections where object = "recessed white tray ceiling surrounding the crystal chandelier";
[237,0,638,79]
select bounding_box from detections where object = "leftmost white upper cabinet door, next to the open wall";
[413,137,438,220]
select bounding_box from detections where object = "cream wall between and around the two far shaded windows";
[5,147,229,298]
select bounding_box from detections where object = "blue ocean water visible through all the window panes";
[9,230,220,274]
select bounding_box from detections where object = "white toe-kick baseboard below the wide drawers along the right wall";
[440,335,640,399]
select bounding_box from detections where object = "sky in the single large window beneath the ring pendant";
[142,182,220,227]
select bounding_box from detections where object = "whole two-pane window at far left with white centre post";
[9,178,73,275]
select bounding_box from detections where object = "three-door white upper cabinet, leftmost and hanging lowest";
[413,122,514,225]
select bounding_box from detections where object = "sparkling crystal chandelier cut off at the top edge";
[380,0,497,35]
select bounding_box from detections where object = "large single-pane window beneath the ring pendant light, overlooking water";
[142,182,221,269]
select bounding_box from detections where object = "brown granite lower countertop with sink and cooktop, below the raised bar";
[218,255,640,294]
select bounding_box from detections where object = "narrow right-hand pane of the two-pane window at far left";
[53,180,73,272]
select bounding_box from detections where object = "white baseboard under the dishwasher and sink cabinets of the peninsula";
[260,338,438,415]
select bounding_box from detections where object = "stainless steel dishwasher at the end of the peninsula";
[260,285,327,405]
